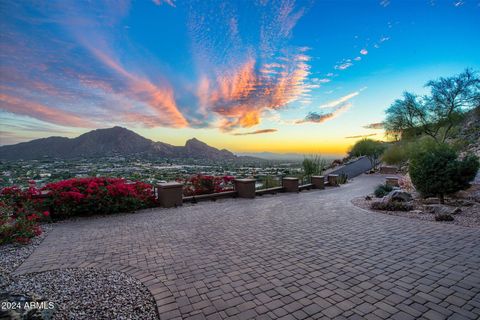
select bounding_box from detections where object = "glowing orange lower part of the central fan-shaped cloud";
[197,54,310,131]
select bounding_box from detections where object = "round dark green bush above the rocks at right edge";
[409,144,479,203]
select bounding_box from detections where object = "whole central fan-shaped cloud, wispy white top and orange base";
[184,0,312,131]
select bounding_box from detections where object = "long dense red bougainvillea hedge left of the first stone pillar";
[42,177,156,217]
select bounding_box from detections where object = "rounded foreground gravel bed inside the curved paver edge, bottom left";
[7,269,158,319]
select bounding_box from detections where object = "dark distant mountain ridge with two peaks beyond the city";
[0,127,239,160]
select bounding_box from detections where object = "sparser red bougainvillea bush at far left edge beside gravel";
[0,184,50,244]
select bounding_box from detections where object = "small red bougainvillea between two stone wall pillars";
[177,174,235,196]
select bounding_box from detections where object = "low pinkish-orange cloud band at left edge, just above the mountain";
[0,94,96,127]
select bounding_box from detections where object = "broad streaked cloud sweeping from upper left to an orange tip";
[0,1,189,127]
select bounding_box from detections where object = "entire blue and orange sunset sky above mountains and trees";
[0,0,480,154]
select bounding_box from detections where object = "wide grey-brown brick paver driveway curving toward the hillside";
[17,176,480,319]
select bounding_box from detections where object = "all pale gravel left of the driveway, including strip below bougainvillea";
[0,224,158,320]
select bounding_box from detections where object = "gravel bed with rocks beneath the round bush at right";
[352,195,480,228]
